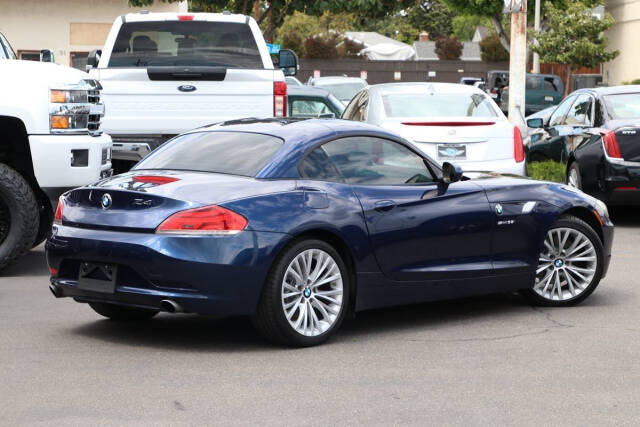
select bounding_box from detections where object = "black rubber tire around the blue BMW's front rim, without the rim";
[522,215,604,307]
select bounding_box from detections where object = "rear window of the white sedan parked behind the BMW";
[382,93,496,117]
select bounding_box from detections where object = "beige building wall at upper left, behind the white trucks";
[0,0,187,65]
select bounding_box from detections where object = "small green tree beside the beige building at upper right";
[531,2,620,93]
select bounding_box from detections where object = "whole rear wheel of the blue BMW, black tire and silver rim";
[253,239,349,347]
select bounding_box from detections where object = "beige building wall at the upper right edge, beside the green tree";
[603,0,640,86]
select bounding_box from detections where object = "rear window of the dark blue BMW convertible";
[135,132,282,176]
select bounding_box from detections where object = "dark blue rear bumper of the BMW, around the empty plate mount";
[45,225,287,315]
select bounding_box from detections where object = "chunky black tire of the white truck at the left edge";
[0,163,40,271]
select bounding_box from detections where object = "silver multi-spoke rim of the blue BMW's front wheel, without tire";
[533,227,598,301]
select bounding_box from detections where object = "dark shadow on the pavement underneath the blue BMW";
[71,290,624,352]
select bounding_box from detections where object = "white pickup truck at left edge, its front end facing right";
[0,34,111,270]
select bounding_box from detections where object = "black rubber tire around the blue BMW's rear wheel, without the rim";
[252,239,350,347]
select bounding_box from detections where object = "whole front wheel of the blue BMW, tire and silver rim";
[524,216,604,307]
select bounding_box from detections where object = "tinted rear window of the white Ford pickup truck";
[109,21,264,68]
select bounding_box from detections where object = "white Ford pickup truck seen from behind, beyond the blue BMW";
[87,12,298,173]
